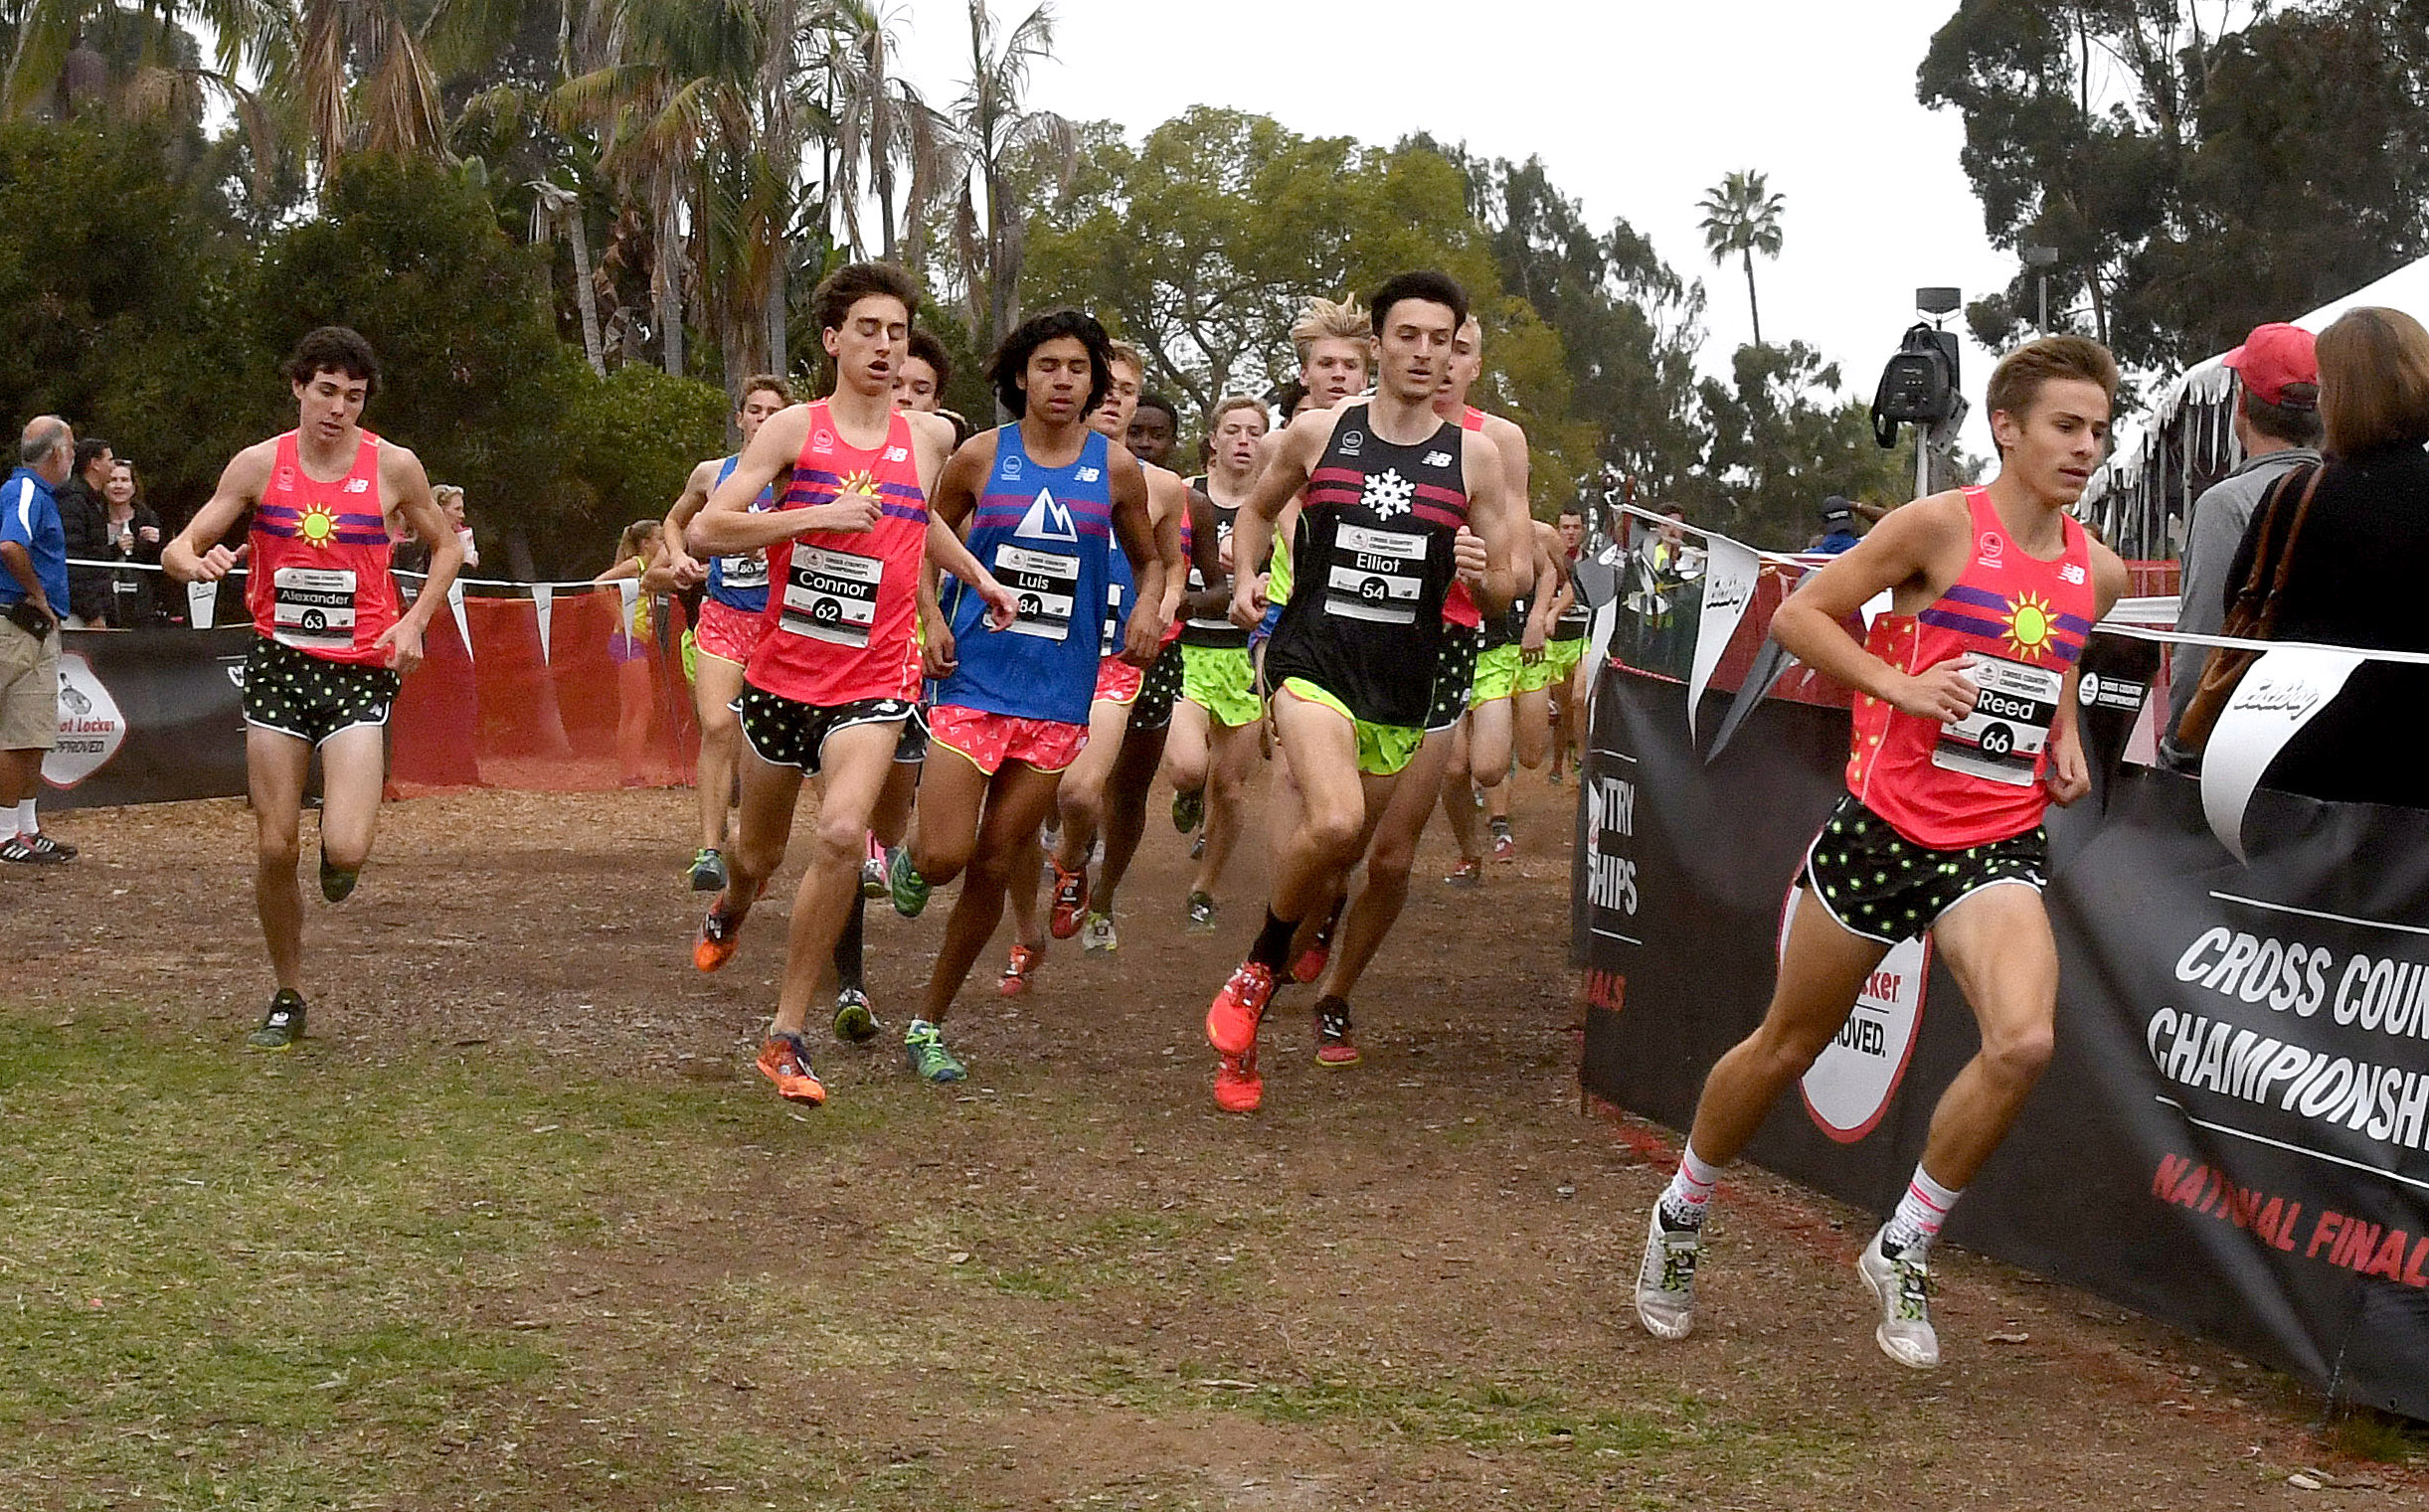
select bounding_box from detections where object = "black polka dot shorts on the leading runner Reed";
[1798,793,2050,944]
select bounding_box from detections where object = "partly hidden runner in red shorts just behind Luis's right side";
[996,342,1190,997]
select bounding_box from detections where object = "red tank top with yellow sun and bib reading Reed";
[1846,488,2096,849]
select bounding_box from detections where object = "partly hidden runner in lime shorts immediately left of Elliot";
[1163,394,1271,934]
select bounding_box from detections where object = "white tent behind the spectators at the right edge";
[2084,257,2429,556]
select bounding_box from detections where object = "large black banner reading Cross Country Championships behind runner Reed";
[1574,655,2429,1418]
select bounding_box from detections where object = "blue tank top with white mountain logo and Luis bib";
[936,424,1120,726]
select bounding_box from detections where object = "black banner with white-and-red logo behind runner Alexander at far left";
[42,623,253,808]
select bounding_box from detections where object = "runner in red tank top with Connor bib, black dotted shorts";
[690,262,1013,1104]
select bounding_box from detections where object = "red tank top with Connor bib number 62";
[746,398,928,706]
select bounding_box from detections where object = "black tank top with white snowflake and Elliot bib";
[1266,406,1468,726]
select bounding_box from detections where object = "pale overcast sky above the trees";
[901,0,2013,451]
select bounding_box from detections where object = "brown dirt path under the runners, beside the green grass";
[0,776,2429,1510]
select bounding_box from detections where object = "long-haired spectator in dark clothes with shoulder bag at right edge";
[2225,306,2429,806]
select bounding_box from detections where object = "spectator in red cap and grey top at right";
[2160,325,2320,769]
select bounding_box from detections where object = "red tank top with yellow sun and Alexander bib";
[246,429,399,665]
